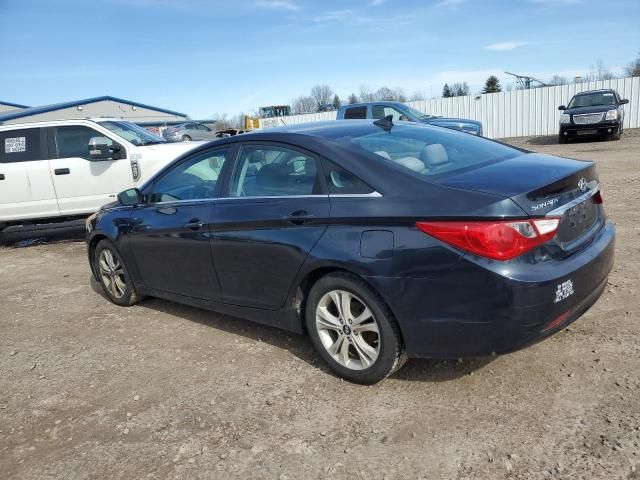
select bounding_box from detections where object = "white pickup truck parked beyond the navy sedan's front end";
[0,118,202,231]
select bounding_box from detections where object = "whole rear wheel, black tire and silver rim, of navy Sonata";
[305,273,406,385]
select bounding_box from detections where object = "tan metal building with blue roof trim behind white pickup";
[0,96,189,127]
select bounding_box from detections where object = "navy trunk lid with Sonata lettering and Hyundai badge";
[439,153,604,252]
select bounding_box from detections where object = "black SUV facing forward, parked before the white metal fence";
[558,89,629,143]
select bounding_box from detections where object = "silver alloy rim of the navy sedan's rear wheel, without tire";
[316,290,380,370]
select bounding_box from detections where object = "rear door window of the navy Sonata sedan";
[229,145,320,197]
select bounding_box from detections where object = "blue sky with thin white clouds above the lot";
[0,0,640,118]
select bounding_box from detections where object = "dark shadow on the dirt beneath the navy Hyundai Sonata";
[90,277,495,382]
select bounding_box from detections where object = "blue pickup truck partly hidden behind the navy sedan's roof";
[337,102,482,136]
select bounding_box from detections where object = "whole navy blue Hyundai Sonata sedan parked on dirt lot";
[87,117,615,384]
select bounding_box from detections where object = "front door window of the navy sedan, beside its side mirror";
[150,150,228,203]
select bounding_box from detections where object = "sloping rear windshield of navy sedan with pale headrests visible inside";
[318,124,524,176]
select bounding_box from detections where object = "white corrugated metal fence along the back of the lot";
[260,77,640,138]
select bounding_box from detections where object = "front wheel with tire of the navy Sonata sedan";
[93,240,143,307]
